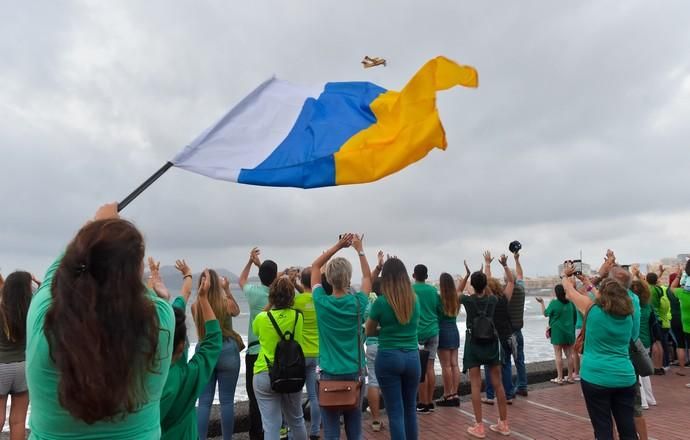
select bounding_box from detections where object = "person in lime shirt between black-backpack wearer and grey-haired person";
[294,267,321,439]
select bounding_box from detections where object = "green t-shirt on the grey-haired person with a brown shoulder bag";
[312,284,369,375]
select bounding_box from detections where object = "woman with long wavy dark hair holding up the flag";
[26,203,175,439]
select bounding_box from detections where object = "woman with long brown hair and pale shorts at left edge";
[0,271,40,440]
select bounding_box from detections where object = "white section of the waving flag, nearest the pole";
[172,78,324,182]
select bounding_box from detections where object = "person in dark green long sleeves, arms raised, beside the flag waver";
[151,260,223,440]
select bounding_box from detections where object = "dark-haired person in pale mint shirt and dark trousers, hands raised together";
[238,247,278,440]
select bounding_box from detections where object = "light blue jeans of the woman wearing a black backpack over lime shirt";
[253,371,307,440]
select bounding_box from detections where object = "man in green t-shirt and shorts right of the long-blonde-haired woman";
[412,264,441,414]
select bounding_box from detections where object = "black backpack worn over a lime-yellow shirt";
[264,310,306,394]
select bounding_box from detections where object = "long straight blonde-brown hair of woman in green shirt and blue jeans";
[381,258,417,324]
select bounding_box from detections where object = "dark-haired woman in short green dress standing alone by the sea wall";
[536,284,577,385]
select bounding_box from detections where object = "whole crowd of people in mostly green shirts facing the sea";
[0,204,690,440]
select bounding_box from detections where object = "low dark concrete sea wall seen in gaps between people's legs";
[208,361,556,437]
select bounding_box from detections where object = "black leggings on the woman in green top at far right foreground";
[580,380,637,440]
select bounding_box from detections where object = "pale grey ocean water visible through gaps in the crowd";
[187,287,554,403]
